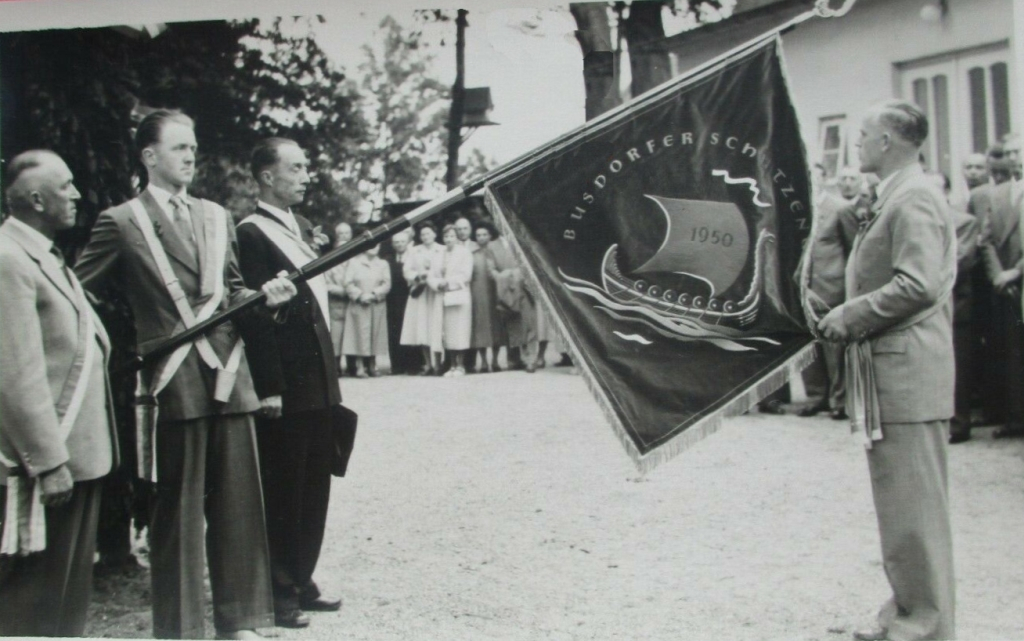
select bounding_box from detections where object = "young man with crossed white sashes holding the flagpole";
[77,110,295,638]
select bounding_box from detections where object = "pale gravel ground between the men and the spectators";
[88,368,1024,641]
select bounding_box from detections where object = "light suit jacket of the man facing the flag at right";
[842,164,956,423]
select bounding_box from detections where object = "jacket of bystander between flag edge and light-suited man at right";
[808,189,857,307]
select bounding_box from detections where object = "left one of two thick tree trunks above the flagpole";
[569,2,623,120]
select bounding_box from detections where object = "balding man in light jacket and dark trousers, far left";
[0,151,118,637]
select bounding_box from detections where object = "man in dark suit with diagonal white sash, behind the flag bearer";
[238,138,341,628]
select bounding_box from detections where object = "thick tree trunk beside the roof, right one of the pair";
[620,0,672,96]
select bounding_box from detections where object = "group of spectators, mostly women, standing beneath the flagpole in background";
[326,217,571,378]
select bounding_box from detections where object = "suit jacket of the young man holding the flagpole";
[75,190,269,422]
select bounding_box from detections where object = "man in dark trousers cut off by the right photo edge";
[979,139,1024,437]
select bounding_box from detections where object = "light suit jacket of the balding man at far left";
[0,221,118,484]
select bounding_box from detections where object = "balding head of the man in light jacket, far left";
[4,149,82,238]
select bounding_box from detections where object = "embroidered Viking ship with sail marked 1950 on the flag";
[601,196,775,329]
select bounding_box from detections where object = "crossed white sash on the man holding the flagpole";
[129,199,243,482]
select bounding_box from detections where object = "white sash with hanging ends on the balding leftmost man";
[0,267,98,555]
